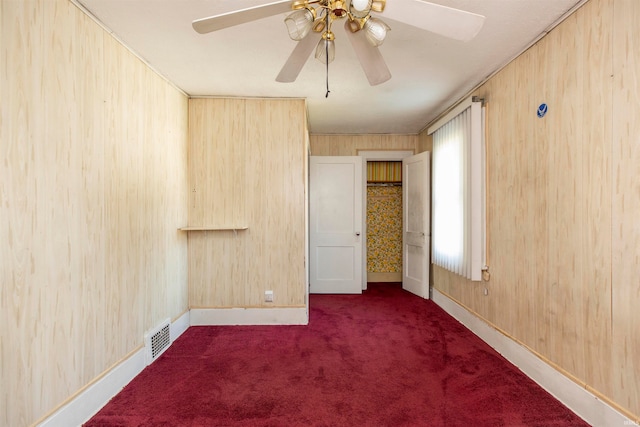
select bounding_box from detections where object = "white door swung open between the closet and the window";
[402,152,431,298]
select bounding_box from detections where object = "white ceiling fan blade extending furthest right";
[382,0,485,42]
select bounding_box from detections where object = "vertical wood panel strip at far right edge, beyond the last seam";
[611,0,640,419]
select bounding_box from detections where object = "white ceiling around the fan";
[75,0,583,134]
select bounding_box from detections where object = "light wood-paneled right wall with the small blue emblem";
[433,0,640,419]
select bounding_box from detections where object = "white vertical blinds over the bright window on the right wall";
[432,99,484,280]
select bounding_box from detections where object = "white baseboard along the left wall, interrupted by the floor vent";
[38,311,189,427]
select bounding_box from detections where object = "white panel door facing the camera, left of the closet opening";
[309,156,362,294]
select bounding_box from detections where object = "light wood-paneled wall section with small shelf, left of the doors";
[189,98,308,308]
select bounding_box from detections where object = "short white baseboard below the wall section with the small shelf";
[191,307,309,326]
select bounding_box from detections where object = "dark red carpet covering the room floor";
[86,284,587,427]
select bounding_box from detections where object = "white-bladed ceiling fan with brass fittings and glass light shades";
[192,0,485,86]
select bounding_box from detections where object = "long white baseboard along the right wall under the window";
[432,289,635,426]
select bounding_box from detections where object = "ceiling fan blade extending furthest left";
[191,0,291,34]
